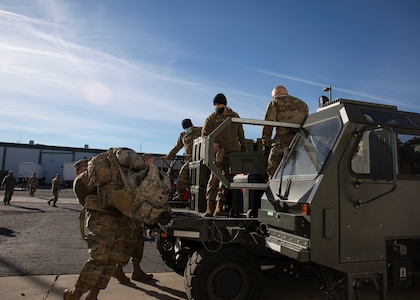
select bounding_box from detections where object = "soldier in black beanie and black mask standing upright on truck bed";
[201,93,246,217]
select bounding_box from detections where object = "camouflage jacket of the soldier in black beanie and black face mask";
[201,107,246,153]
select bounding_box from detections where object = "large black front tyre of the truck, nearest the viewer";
[184,246,261,300]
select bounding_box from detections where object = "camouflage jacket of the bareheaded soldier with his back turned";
[262,95,308,146]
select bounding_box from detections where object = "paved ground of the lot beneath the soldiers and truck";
[0,187,420,300]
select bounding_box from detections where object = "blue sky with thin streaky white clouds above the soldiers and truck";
[0,0,420,154]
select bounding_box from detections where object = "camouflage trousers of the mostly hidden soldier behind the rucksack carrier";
[119,216,144,266]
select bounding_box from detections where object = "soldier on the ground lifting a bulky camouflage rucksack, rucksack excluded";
[63,160,125,300]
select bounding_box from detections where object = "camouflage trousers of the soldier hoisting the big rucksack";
[75,209,124,294]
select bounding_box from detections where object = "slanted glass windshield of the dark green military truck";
[276,118,341,179]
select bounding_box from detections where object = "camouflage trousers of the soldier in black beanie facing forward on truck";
[206,157,231,203]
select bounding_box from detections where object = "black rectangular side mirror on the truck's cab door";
[369,128,395,181]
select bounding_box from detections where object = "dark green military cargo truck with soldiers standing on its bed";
[158,98,420,300]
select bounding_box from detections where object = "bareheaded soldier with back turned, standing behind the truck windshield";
[262,86,308,179]
